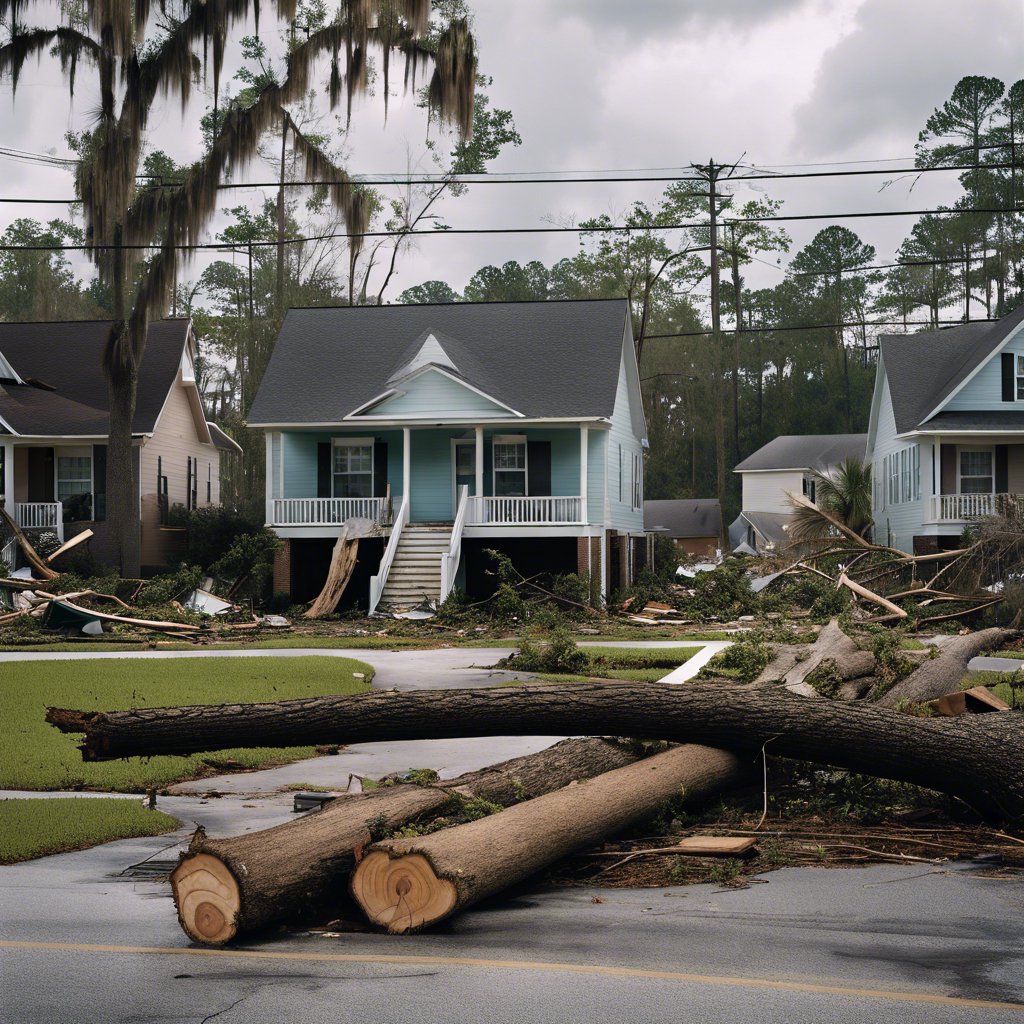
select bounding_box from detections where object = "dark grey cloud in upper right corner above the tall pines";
[794,0,1024,157]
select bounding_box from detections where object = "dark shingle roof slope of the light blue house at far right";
[879,305,1024,433]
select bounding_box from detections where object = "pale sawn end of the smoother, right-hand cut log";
[352,850,458,934]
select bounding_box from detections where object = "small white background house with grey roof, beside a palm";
[729,434,867,554]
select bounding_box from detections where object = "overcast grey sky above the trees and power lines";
[0,0,1024,300]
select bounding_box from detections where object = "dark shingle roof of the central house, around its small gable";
[249,299,629,426]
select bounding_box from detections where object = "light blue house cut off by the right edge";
[867,306,1024,554]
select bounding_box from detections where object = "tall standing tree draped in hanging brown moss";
[0,0,476,575]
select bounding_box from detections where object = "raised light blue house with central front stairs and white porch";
[249,299,646,610]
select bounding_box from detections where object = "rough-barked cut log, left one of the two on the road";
[171,739,640,945]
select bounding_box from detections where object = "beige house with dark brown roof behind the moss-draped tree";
[0,319,241,568]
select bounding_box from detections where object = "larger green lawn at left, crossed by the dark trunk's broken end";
[0,655,373,793]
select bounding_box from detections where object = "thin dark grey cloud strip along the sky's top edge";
[558,0,805,39]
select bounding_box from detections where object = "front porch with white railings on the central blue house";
[266,424,603,538]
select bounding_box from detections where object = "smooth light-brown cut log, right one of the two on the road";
[351,745,744,933]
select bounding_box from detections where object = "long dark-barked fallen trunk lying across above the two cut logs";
[47,680,1024,821]
